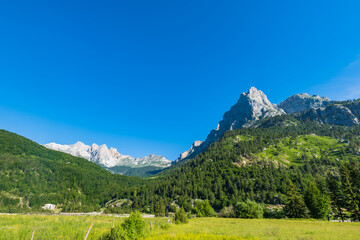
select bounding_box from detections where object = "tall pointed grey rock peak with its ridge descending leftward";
[177,87,285,161]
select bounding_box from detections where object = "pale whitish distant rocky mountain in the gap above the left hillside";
[44,142,171,173]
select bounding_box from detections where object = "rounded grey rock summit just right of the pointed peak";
[280,93,332,114]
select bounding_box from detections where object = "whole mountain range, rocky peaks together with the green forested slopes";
[0,87,360,217]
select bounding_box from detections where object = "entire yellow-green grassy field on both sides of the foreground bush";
[0,215,360,240]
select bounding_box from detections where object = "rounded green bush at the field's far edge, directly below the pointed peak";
[235,199,264,218]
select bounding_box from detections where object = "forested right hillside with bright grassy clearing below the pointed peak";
[124,116,360,217]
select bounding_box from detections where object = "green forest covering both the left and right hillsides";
[0,115,360,221]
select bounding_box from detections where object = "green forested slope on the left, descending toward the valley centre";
[0,130,141,211]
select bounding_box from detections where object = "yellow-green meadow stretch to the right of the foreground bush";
[143,218,360,240]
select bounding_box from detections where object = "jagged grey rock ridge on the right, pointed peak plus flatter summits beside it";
[176,87,360,162]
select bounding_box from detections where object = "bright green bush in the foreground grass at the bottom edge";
[102,212,145,240]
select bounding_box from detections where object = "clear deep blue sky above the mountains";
[0,0,360,159]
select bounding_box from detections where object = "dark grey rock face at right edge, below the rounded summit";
[297,101,360,126]
